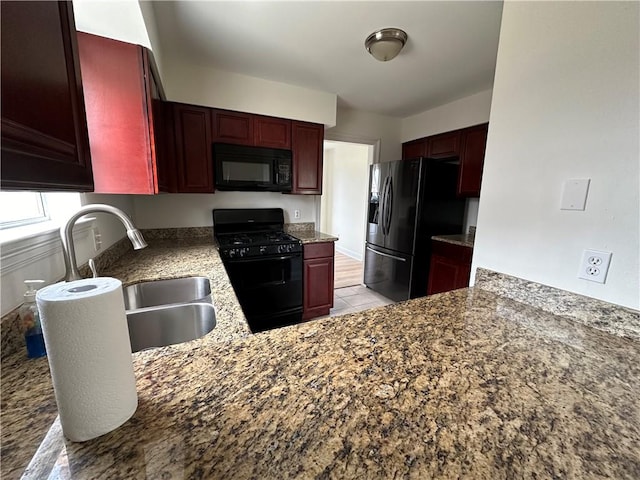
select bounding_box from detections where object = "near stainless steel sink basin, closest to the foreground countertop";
[127,302,216,352]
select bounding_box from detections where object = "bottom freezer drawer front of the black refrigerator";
[364,244,413,302]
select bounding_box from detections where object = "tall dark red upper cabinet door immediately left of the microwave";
[173,103,214,193]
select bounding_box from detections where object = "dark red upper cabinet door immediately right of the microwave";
[291,121,324,195]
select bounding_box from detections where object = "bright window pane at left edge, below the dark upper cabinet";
[0,192,50,229]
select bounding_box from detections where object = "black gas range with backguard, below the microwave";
[213,208,302,332]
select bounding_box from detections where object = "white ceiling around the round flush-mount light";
[154,1,502,117]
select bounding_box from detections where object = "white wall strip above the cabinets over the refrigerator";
[401,90,492,143]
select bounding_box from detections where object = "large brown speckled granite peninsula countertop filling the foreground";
[1,237,640,479]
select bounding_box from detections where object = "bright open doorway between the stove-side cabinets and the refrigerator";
[319,140,375,289]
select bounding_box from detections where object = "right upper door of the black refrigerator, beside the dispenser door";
[382,160,421,254]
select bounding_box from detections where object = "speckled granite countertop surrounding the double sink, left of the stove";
[1,237,251,479]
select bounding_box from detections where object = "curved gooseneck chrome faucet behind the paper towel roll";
[60,203,147,282]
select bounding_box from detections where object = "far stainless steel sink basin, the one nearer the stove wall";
[123,277,211,310]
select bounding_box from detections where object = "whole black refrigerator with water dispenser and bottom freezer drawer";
[364,158,466,301]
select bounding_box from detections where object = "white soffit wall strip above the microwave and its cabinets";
[162,58,337,126]
